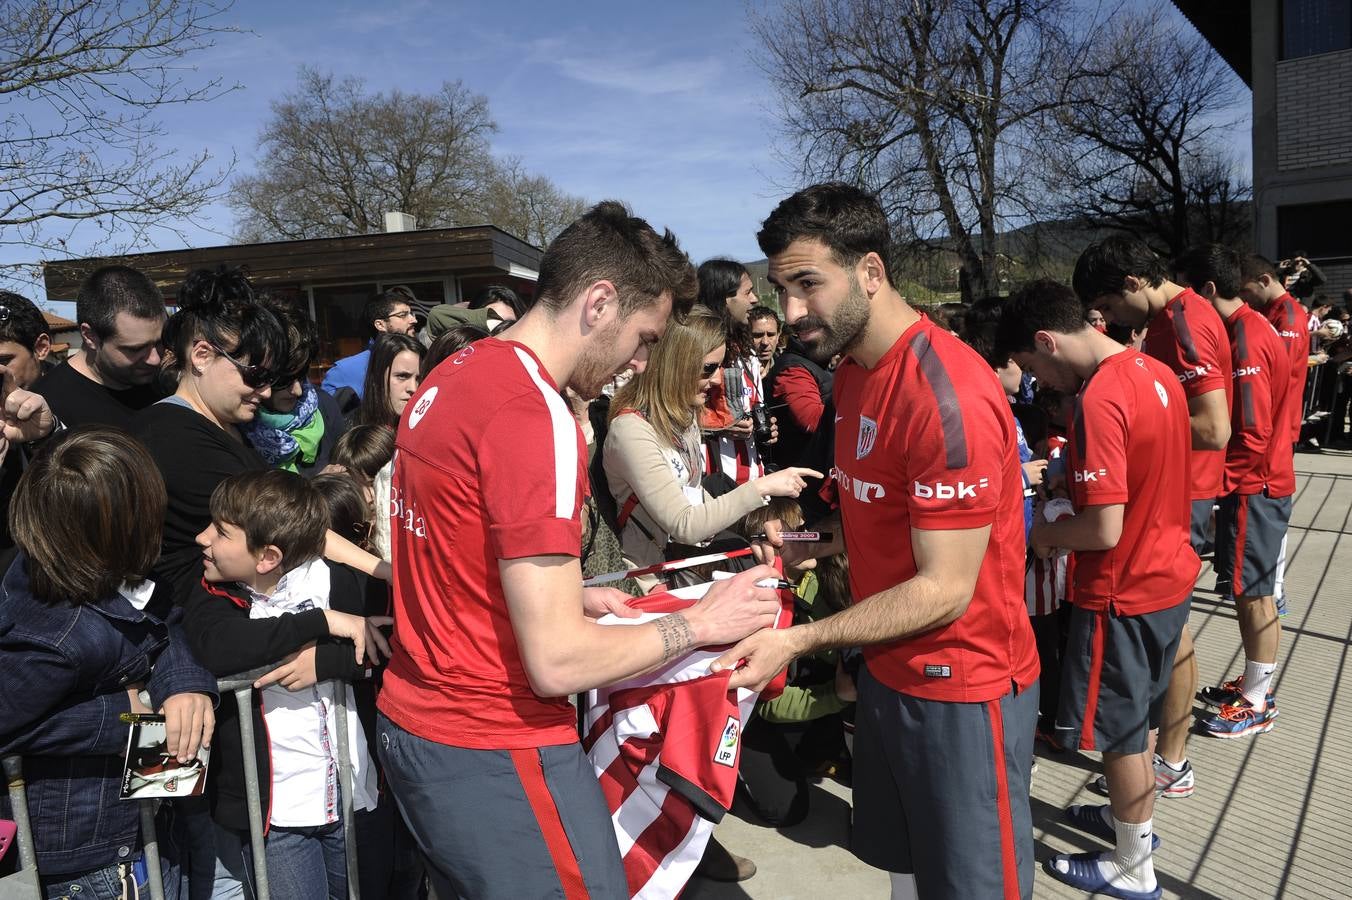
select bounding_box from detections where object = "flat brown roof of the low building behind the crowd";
[42,226,542,300]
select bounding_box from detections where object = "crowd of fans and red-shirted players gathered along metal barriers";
[0,185,1330,899]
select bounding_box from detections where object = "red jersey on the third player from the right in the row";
[1141,288,1233,500]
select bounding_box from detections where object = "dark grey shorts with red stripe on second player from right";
[1215,493,1294,597]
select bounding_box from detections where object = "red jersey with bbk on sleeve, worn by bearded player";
[834,318,1038,703]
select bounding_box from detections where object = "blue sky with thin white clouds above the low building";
[7,0,1243,308]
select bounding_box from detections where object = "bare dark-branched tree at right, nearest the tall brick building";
[1051,5,1249,255]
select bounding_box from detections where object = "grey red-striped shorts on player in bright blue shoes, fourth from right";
[1056,597,1192,753]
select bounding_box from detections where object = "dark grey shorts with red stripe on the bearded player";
[850,665,1037,900]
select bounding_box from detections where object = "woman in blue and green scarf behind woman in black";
[245,299,347,478]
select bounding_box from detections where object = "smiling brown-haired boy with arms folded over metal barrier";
[184,469,389,897]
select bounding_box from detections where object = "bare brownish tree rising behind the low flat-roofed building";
[230,68,496,241]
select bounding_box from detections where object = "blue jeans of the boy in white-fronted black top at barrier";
[211,822,347,900]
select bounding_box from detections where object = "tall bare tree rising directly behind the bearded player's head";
[753,0,1076,299]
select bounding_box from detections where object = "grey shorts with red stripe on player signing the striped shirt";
[376,715,629,900]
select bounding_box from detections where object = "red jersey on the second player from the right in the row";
[1225,305,1295,497]
